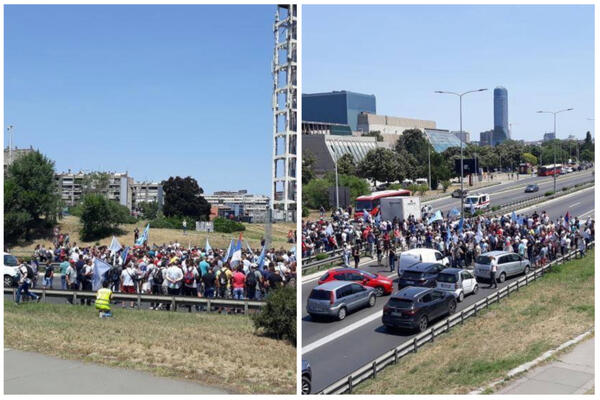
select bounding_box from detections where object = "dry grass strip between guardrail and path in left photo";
[4,302,296,393]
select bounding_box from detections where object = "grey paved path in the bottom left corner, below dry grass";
[4,349,226,394]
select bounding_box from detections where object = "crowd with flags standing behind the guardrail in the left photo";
[21,241,296,310]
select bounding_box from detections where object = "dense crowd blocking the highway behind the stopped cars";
[302,209,595,269]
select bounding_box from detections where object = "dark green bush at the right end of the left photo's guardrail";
[252,286,296,345]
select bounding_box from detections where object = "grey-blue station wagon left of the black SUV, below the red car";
[306,281,376,321]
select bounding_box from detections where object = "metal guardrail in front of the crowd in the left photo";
[4,287,266,314]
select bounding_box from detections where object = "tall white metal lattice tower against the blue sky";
[271,4,298,221]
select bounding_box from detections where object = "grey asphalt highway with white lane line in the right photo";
[302,184,594,392]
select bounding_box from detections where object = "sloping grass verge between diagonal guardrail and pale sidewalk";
[356,251,594,394]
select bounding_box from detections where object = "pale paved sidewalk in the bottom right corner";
[497,338,594,394]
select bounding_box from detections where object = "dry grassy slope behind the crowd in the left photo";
[10,216,296,257]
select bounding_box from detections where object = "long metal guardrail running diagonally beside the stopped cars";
[319,241,595,394]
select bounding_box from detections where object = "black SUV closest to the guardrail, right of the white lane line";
[381,287,456,332]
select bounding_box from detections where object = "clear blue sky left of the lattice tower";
[4,5,275,196]
